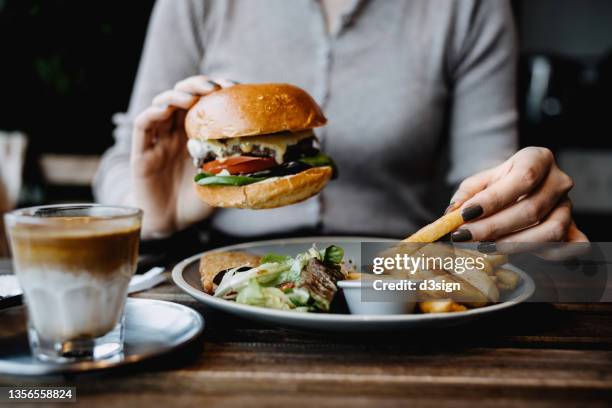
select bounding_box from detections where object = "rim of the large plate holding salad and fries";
[172,236,535,324]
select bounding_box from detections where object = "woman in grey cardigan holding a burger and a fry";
[95,0,586,242]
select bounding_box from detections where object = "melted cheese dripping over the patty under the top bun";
[187,130,314,164]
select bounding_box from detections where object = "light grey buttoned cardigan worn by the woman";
[94,0,517,236]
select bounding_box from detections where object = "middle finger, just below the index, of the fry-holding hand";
[451,170,567,242]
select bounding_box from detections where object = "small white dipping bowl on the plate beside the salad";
[338,280,417,315]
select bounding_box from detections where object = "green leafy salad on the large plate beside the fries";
[214,245,345,312]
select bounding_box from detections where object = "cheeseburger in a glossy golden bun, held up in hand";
[185,84,336,209]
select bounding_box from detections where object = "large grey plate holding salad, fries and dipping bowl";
[172,237,535,332]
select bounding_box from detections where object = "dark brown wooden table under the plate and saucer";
[0,272,612,408]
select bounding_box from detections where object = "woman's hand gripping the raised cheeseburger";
[129,75,234,236]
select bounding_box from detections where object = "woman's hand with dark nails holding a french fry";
[447,147,588,250]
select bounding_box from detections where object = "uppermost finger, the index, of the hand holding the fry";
[463,147,553,221]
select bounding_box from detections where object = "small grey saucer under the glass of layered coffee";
[0,298,204,375]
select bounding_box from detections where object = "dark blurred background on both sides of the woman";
[0,0,612,241]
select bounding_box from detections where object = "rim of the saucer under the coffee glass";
[0,297,206,376]
